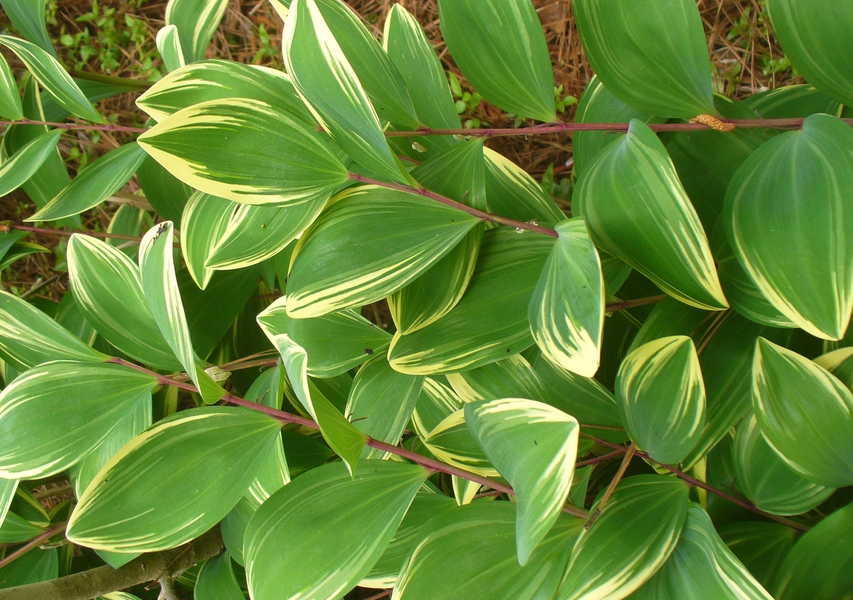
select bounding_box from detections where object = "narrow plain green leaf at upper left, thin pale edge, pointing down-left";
[25,142,145,221]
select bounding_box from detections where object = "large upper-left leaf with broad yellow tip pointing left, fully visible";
[138,98,348,205]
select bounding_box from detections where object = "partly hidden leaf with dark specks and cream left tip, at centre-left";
[258,296,391,378]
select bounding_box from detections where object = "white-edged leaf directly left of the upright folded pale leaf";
[67,235,181,371]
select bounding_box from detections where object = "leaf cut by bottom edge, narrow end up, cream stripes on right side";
[631,503,773,600]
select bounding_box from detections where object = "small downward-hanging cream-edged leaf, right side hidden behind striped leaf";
[181,192,231,290]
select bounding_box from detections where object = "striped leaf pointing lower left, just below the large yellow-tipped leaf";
[207,196,327,270]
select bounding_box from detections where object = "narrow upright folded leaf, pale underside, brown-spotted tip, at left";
[139,221,225,404]
